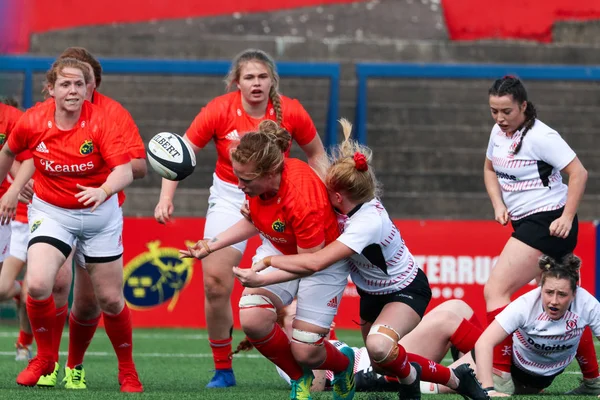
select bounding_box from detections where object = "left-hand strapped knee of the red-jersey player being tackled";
[239,294,277,338]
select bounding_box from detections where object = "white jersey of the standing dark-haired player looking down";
[486,120,576,220]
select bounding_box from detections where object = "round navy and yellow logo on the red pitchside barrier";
[123,240,194,311]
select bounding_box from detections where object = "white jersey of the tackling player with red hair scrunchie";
[337,199,419,295]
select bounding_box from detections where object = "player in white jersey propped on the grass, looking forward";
[475,254,600,396]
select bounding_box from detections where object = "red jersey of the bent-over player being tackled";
[248,158,340,254]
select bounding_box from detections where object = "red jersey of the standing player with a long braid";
[186,90,317,184]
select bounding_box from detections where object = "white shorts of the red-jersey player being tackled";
[252,240,350,328]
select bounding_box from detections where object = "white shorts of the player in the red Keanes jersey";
[28,196,123,264]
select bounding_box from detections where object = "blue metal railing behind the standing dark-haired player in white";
[355,63,600,143]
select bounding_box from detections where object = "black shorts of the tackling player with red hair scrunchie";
[356,268,431,322]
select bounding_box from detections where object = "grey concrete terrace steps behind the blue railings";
[0,0,600,219]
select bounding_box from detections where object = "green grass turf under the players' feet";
[0,326,592,400]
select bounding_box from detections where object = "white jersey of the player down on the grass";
[496,287,600,376]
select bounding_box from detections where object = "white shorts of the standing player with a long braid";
[204,174,248,254]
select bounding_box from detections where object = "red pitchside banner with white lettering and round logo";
[123,218,596,328]
